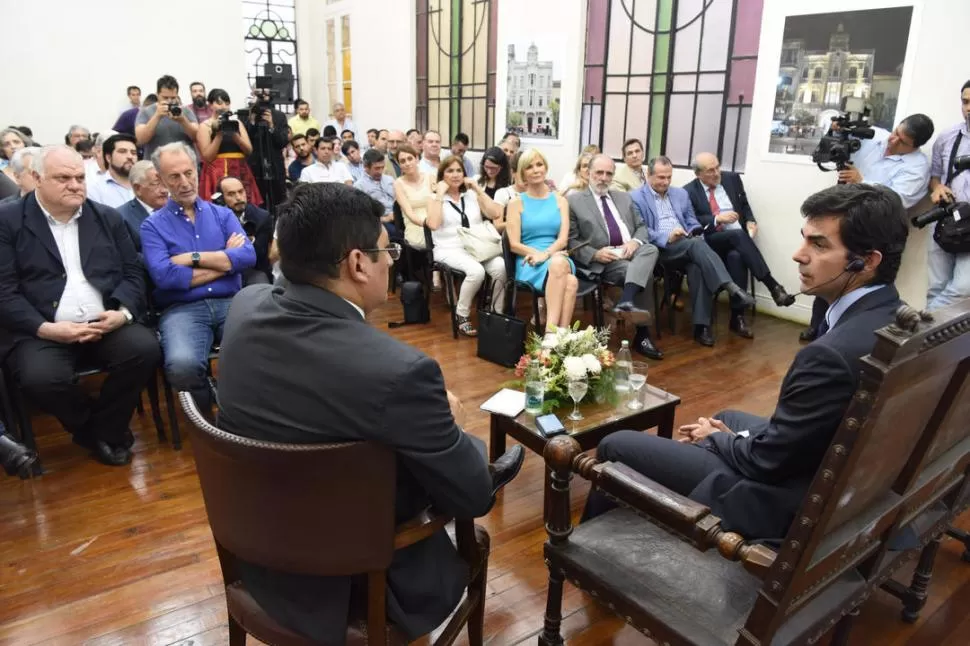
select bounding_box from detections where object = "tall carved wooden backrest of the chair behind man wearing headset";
[745,301,970,643]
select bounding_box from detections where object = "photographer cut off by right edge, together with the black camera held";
[913,81,970,310]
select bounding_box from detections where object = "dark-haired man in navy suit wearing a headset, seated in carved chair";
[585,184,909,540]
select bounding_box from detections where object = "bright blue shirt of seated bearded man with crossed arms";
[141,198,256,308]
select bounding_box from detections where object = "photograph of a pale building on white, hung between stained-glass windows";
[505,3,565,139]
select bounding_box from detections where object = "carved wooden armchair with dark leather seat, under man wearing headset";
[539,302,970,646]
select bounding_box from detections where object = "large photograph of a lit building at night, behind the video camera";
[768,6,913,155]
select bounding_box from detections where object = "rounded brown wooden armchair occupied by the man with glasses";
[179,392,489,646]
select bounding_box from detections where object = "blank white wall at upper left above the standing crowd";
[0,0,249,143]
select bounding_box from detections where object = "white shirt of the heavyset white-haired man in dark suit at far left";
[37,198,104,323]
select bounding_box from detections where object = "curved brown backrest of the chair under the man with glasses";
[179,392,396,585]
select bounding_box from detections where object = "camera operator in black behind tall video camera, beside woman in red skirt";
[246,88,290,212]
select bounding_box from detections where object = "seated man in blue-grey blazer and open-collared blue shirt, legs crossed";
[630,156,754,347]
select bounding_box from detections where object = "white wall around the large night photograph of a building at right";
[736,0,970,321]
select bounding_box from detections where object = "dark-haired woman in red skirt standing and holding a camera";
[196,88,263,206]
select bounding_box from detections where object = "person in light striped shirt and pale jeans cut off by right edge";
[926,81,970,310]
